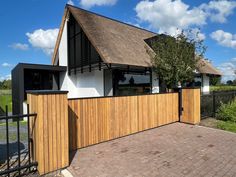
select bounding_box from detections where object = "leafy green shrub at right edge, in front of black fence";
[216,100,236,122]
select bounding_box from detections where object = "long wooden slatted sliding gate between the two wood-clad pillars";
[68,93,179,150]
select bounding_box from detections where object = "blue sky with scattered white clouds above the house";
[0,0,236,80]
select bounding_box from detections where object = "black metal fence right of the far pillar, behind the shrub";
[201,90,236,119]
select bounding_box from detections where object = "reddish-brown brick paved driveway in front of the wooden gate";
[68,123,236,177]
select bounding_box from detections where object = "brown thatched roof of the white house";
[52,5,221,75]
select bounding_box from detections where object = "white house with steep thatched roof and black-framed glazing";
[12,5,221,112]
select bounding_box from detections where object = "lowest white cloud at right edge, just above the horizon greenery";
[217,59,236,82]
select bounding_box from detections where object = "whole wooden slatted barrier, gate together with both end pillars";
[27,89,200,175]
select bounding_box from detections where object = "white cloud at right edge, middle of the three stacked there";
[210,30,236,49]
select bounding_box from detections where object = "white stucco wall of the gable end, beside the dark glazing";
[58,19,104,98]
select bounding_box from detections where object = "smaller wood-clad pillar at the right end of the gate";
[181,89,201,124]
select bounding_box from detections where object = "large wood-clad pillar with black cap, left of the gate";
[27,92,69,175]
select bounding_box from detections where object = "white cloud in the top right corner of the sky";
[200,0,236,23]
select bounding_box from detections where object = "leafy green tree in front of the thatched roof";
[151,31,206,89]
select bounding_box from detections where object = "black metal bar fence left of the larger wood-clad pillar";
[0,105,37,176]
